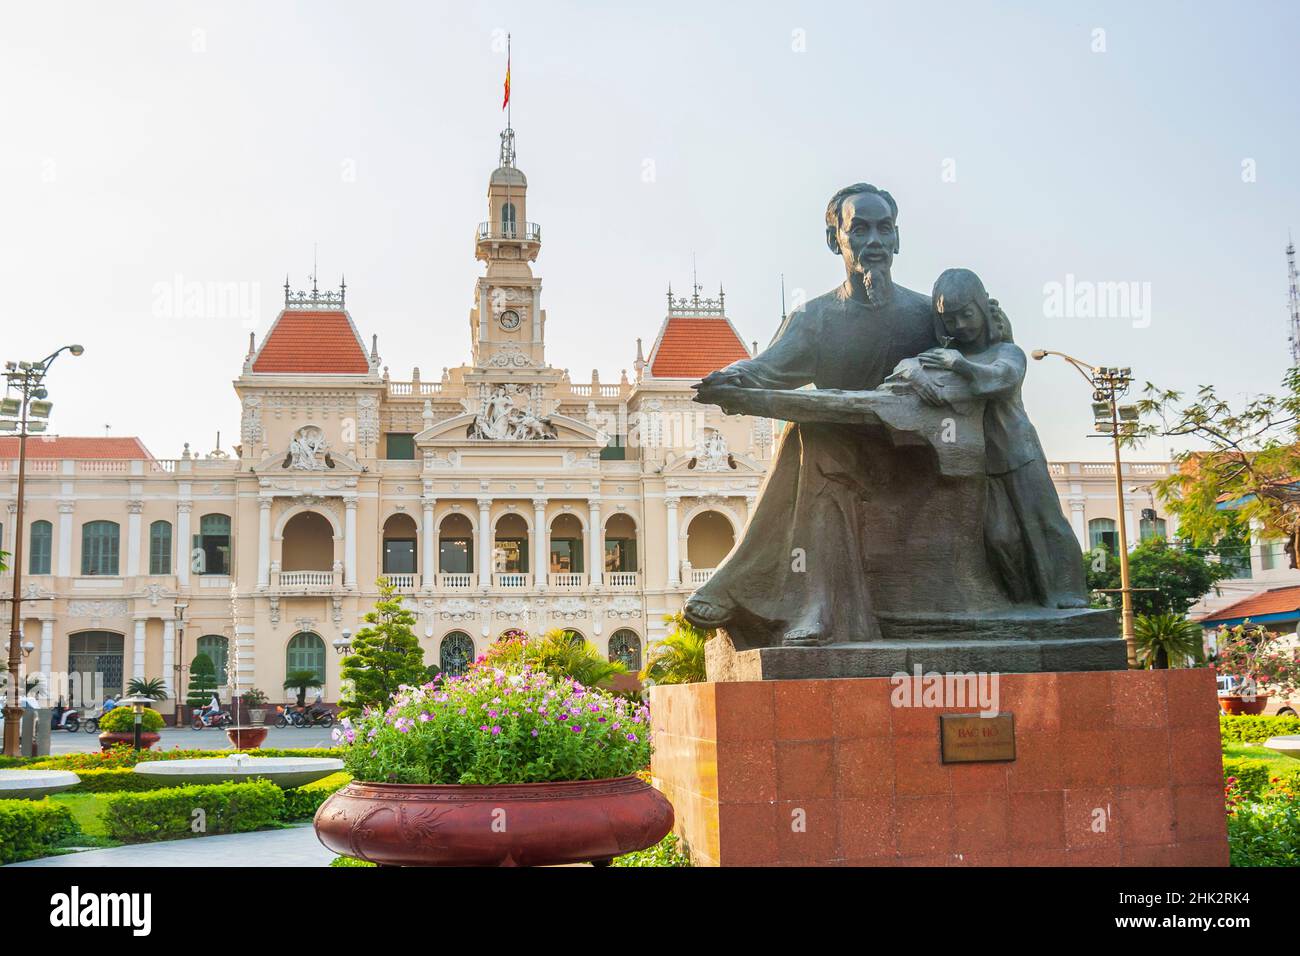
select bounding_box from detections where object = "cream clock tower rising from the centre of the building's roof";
[469,127,546,373]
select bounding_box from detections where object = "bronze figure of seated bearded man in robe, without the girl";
[684,182,943,649]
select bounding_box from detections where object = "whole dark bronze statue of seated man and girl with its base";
[684,183,1125,678]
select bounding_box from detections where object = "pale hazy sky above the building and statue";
[0,0,1300,460]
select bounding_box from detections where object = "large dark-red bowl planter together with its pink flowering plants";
[315,659,673,866]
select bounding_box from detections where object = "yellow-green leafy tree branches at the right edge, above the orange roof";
[1139,367,1300,567]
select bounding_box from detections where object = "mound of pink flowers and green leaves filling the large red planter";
[341,662,650,784]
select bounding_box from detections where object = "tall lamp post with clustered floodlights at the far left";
[0,345,85,757]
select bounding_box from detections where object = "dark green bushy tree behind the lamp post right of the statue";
[1083,537,1231,617]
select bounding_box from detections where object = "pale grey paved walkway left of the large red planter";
[5,823,334,869]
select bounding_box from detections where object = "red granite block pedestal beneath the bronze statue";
[650,669,1229,866]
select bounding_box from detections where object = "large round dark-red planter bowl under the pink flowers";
[313,777,673,866]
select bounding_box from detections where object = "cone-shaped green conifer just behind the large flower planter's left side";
[341,578,426,717]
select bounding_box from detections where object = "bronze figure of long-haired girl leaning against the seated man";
[900,269,1088,607]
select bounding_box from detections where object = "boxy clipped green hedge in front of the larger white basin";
[103,780,285,843]
